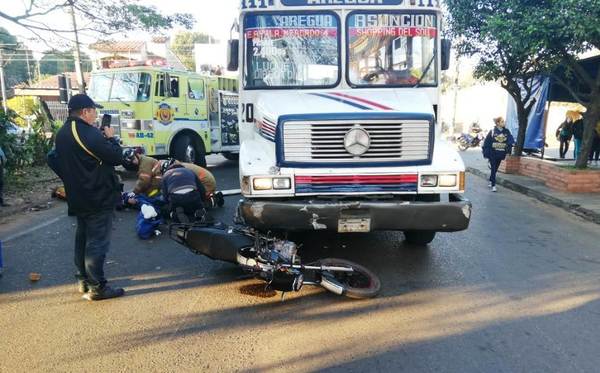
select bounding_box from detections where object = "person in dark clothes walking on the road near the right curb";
[483,117,515,192]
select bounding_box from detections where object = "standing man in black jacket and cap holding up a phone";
[56,94,125,300]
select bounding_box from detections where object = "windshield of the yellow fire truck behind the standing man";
[89,72,151,102]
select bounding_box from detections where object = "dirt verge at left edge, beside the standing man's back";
[0,166,64,224]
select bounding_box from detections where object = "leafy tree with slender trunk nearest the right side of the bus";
[446,0,545,156]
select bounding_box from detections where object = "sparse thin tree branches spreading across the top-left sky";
[0,0,195,46]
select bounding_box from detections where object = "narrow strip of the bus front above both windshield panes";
[240,0,441,13]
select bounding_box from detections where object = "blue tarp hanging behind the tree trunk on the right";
[506,77,550,150]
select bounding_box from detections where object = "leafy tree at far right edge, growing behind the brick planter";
[531,0,600,168]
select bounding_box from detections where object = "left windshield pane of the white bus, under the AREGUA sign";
[244,12,340,89]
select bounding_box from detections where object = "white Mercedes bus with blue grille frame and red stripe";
[228,0,471,244]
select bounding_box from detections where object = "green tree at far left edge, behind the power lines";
[0,27,35,87]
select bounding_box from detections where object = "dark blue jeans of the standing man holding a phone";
[75,211,113,290]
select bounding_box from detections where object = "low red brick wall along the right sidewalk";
[500,156,600,193]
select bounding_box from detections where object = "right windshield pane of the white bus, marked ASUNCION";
[348,12,437,87]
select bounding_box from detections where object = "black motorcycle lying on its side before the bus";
[169,219,381,299]
